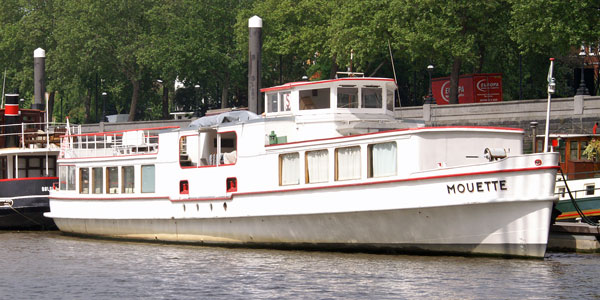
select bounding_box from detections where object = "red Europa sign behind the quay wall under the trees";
[431,73,502,105]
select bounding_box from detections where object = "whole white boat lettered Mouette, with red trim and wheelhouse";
[46,77,558,257]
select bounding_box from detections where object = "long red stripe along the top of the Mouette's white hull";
[50,166,560,202]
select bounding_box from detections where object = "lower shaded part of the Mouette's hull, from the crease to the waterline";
[50,199,553,257]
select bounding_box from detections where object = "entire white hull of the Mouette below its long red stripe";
[48,159,556,257]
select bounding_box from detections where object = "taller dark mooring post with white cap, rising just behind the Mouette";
[248,16,263,114]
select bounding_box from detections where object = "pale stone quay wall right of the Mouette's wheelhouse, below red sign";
[394,96,600,152]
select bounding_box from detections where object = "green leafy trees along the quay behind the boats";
[0,0,600,122]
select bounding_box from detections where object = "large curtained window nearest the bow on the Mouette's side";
[368,142,397,177]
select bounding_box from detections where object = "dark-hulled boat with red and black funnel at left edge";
[0,94,65,230]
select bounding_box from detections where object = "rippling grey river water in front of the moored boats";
[0,232,600,299]
